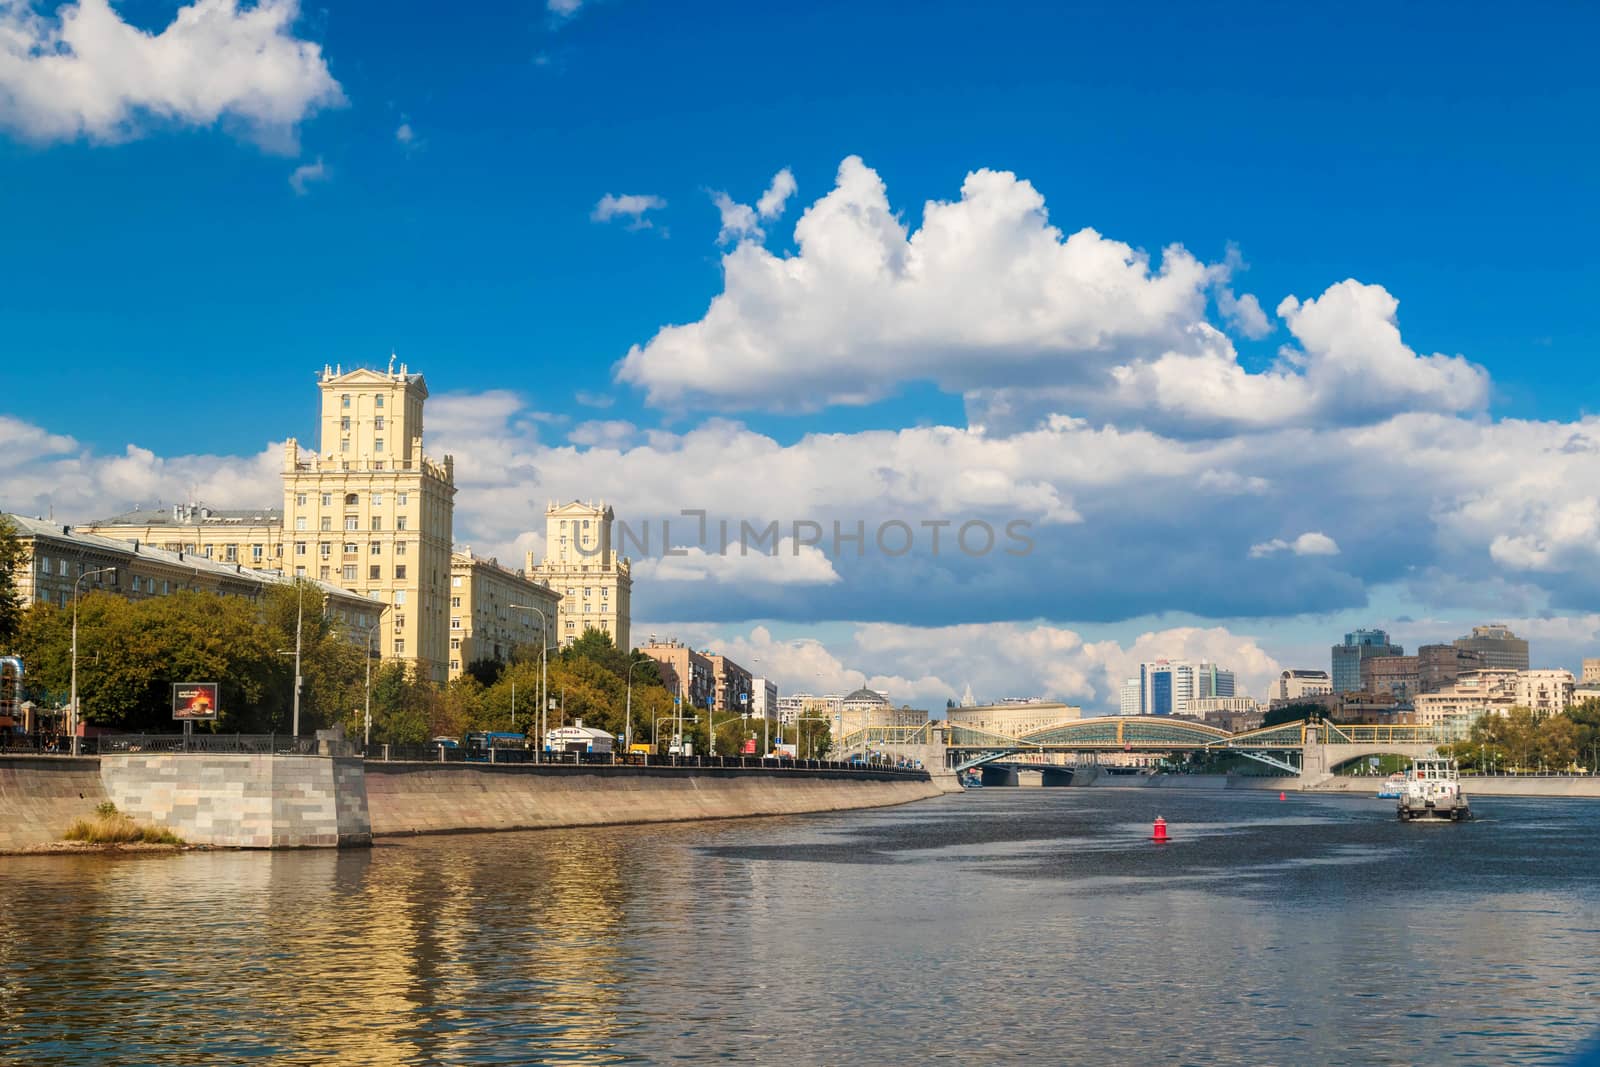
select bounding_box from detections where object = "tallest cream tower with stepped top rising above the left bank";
[282,362,456,681]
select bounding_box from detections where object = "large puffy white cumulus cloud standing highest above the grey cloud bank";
[616,157,1488,434]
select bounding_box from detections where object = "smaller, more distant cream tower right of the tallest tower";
[526,501,634,651]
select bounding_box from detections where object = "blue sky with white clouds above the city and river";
[0,0,1600,702]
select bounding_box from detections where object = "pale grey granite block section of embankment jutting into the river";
[99,753,371,848]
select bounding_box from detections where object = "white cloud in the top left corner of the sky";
[0,0,344,150]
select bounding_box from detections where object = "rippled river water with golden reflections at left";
[0,789,1600,1067]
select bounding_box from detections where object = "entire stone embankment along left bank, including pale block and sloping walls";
[0,753,942,851]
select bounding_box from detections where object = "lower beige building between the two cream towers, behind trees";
[450,549,562,678]
